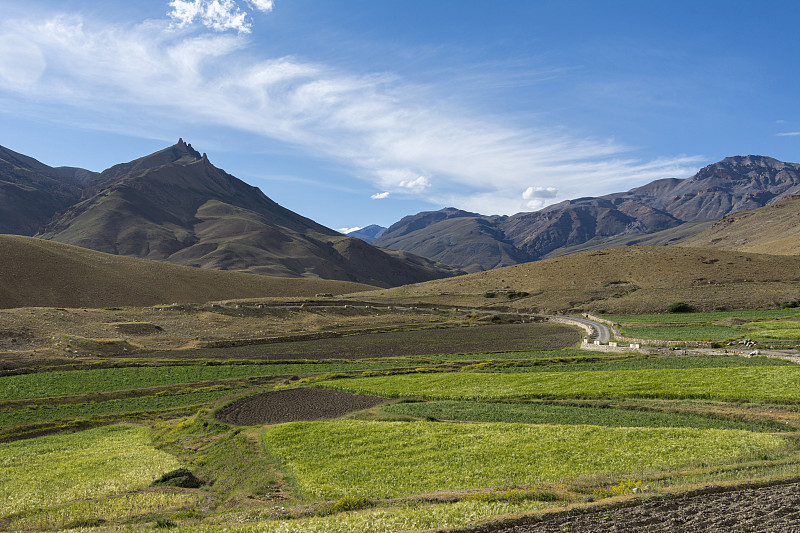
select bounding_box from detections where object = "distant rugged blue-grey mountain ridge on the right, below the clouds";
[375,156,800,272]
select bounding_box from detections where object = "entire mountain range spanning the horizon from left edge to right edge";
[0,140,800,287]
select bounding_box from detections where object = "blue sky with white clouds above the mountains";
[0,0,800,229]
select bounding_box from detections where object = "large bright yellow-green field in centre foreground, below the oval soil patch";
[264,421,786,499]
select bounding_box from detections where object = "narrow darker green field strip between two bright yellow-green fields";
[382,400,787,432]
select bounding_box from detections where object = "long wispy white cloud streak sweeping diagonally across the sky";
[0,9,701,214]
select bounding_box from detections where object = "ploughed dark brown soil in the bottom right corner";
[456,480,800,533]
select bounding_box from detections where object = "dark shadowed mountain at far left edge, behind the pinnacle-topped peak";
[0,146,95,235]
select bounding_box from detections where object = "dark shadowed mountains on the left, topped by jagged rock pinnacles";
[0,140,459,287]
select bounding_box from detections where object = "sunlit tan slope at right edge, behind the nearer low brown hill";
[681,195,800,255]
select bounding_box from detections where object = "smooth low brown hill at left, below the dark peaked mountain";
[0,235,369,308]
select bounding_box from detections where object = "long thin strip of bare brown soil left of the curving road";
[144,324,580,360]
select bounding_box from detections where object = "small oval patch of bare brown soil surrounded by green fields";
[217,388,391,426]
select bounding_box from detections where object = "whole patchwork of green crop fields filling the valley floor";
[0,304,800,533]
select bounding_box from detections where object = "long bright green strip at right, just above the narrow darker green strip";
[316,366,800,402]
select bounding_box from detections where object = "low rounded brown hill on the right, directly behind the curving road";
[360,246,800,313]
